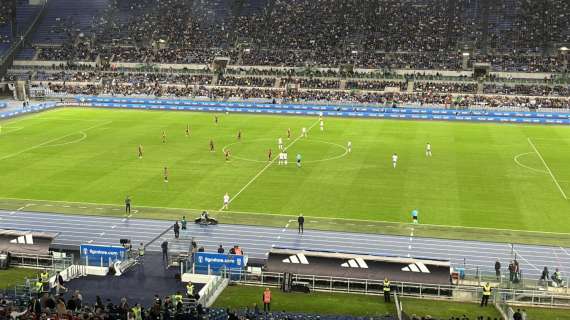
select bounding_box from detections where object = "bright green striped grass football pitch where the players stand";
[0,108,570,233]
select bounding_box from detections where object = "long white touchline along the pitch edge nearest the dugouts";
[0,197,570,236]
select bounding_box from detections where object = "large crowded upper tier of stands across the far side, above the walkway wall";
[8,0,570,72]
